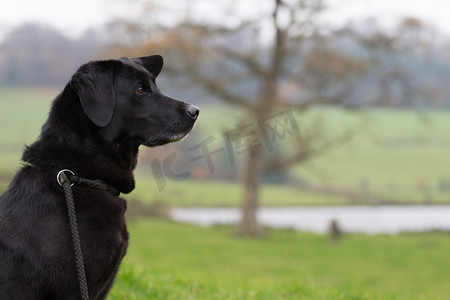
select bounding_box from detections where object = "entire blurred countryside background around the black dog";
[0,0,450,299]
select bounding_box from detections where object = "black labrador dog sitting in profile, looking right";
[0,55,199,300]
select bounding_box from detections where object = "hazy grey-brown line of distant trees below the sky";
[0,18,450,108]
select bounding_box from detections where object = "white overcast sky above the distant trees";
[0,0,450,36]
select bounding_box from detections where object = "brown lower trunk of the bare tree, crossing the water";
[237,147,263,237]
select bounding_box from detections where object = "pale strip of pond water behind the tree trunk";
[171,205,450,234]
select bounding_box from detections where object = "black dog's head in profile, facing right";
[70,55,199,147]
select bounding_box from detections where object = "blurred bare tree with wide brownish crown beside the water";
[106,0,432,236]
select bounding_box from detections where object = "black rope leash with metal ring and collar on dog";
[56,169,120,300]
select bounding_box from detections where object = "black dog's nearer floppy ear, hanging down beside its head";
[70,60,116,127]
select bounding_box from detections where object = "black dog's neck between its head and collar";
[22,85,139,193]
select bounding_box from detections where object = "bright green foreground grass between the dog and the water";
[109,220,450,299]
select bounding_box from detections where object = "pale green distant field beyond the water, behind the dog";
[0,88,450,206]
